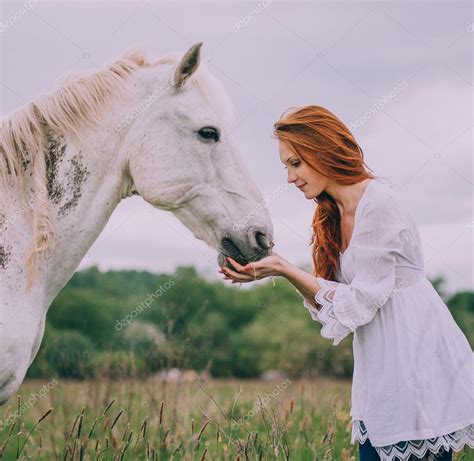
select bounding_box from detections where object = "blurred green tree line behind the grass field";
[27,267,474,379]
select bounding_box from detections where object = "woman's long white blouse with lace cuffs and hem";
[298,178,474,461]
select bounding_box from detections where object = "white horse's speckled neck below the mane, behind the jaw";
[0,128,129,315]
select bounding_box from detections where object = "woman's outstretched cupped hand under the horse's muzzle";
[219,253,288,283]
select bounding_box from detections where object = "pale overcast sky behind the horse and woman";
[0,0,474,292]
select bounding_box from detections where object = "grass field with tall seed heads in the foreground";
[0,378,474,461]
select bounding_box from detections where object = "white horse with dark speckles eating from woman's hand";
[0,43,273,404]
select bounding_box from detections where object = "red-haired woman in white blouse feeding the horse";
[221,106,474,461]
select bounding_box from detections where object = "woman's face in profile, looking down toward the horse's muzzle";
[279,141,329,200]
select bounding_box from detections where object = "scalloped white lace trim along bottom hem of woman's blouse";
[351,420,474,461]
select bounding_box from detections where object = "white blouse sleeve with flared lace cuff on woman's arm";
[303,201,405,346]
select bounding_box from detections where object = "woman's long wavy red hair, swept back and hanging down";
[274,105,376,280]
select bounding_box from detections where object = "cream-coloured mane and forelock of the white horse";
[0,50,234,288]
